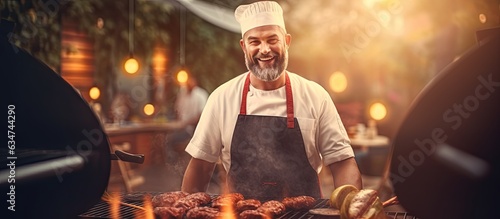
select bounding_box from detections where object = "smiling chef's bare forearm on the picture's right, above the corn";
[329,157,363,189]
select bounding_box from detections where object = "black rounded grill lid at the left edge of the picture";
[0,20,110,218]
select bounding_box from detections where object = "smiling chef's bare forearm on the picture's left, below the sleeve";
[181,158,215,193]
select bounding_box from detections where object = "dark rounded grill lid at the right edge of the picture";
[390,29,500,219]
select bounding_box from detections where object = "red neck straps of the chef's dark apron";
[240,72,295,129]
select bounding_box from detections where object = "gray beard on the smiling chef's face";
[245,51,288,81]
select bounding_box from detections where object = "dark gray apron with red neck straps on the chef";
[228,73,321,200]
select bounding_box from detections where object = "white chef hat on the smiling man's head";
[234,1,286,36]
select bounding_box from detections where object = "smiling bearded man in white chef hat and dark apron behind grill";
[182,1,362,199]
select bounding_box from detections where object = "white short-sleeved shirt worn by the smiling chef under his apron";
[186,72,354,173]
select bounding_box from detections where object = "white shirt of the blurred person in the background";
[176,87,208,134]
